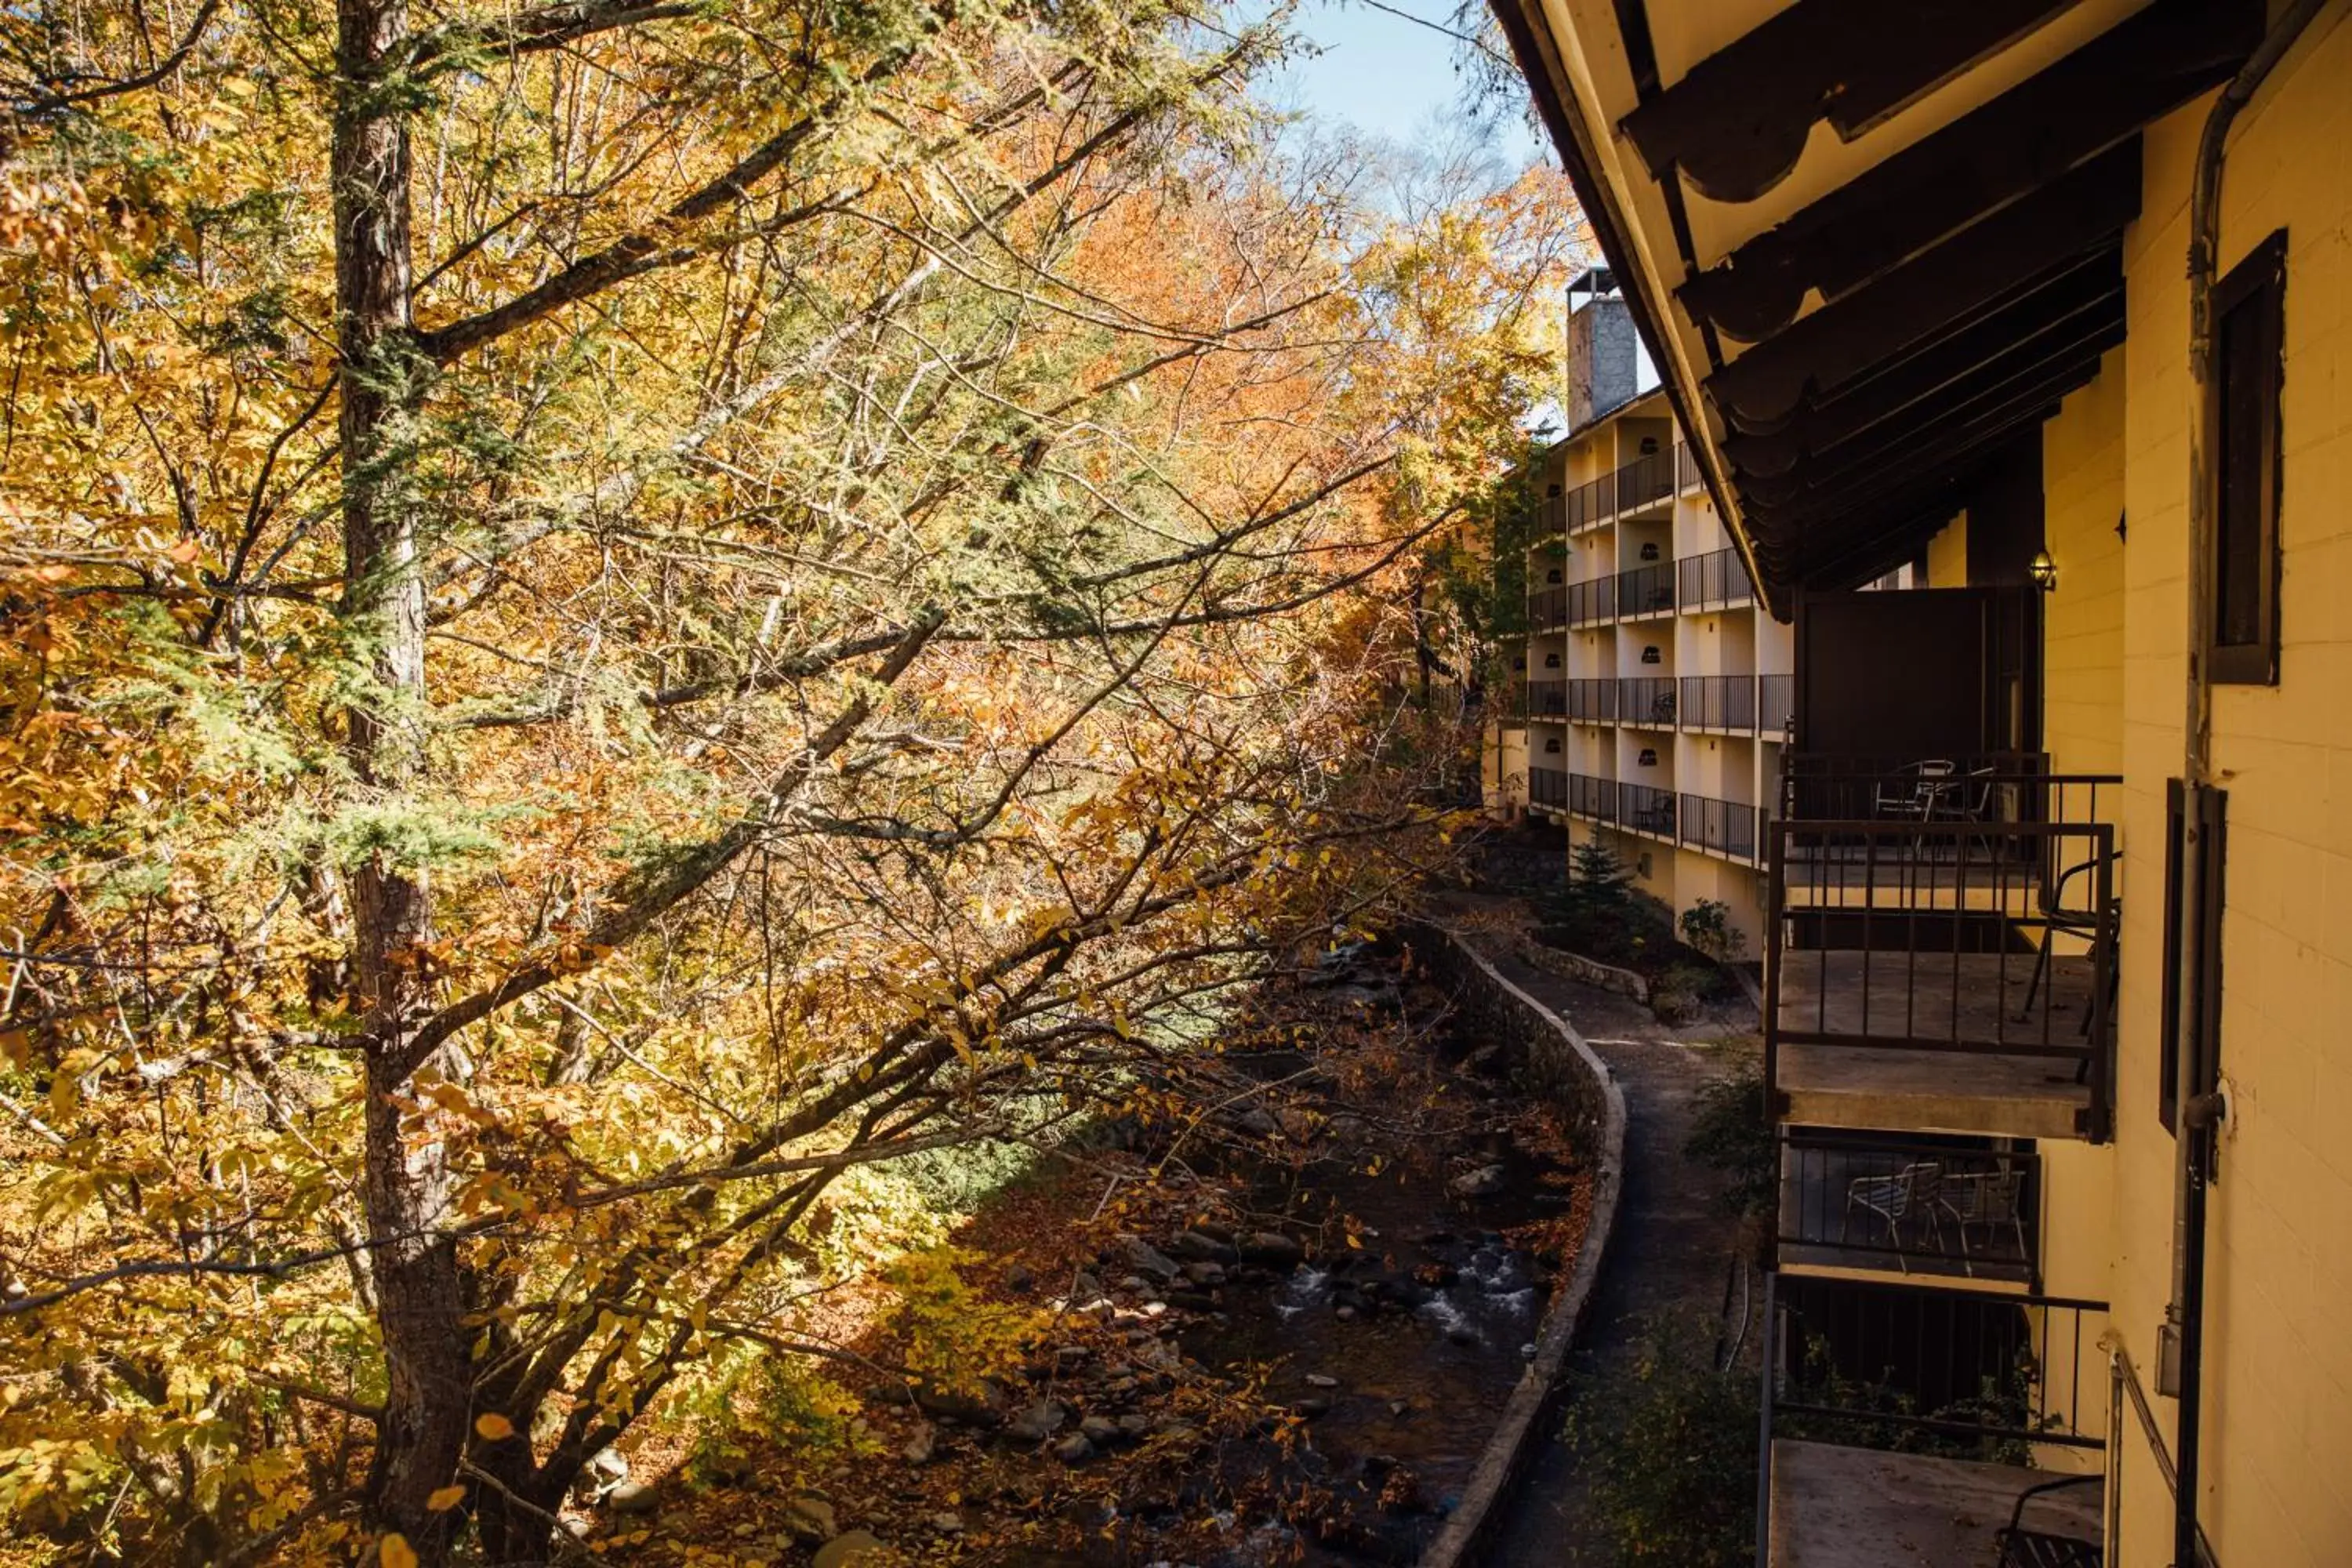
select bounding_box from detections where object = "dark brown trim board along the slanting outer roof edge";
[1489,0,1795,621]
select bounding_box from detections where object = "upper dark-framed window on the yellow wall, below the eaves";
[2206,228,2286,687]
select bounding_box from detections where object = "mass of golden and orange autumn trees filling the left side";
[0,0,1573,1561]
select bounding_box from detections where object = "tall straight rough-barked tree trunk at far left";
[334,0,470,1563]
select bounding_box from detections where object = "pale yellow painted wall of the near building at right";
[2044,18,2352,1568]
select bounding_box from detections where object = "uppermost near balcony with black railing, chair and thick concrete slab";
[1764,753,2122,1140]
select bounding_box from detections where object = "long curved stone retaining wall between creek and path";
[1411,926,1625,1568]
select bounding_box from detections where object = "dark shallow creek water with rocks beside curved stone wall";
[1018,1044,1569,1568]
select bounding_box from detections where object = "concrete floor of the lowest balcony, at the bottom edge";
[1766,1439,2103,1568]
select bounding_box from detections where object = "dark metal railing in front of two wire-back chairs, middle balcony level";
[1776,1128,2042,1283]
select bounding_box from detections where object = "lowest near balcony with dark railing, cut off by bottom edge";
[1757,1274,2114,1568]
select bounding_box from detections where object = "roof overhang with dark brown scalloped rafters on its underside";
[1496,0,2263,616]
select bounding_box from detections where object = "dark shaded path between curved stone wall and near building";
[1484,952,1736,1568]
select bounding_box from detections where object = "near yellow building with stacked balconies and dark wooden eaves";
[1496,0,2352,1568]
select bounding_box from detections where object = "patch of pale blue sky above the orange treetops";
[1268,0,1538,169]
